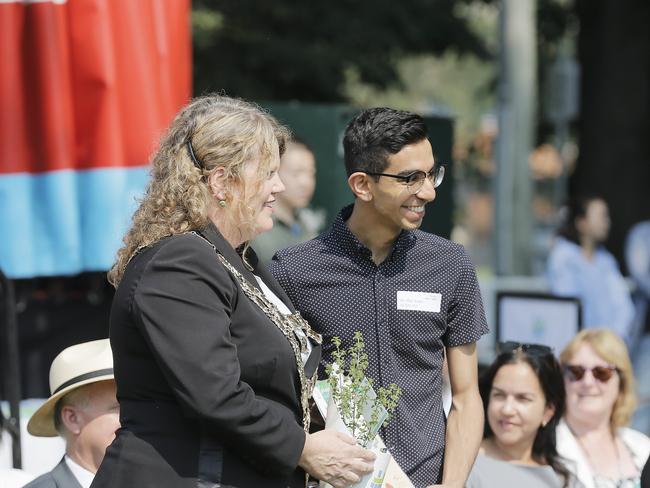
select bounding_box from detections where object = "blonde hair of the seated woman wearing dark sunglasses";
[560,329,637,432]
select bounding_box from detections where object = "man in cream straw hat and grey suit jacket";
[25,339,120,488]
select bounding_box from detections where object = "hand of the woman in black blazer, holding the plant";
[299,430,375,488]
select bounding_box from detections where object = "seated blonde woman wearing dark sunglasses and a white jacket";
[557,329,650,488]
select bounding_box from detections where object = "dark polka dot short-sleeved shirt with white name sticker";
[270,206,488,488]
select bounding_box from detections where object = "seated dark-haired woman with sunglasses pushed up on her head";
[466,342,572,488]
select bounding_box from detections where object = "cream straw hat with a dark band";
[27,339,114,437]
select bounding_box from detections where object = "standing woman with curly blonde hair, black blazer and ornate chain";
[92,95,374,488]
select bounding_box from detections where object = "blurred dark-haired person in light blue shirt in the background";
[547,197,634,341]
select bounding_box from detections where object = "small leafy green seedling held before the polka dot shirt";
[326,331,402,447]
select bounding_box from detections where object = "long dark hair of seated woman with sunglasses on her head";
[479,349,569,486]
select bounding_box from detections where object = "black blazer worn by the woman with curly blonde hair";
[92,225,320,488]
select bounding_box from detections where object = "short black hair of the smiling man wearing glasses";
[343,107,427,176]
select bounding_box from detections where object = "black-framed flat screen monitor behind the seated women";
[496,291,582,356]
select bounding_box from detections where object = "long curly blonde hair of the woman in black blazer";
[108,95,290,287]
